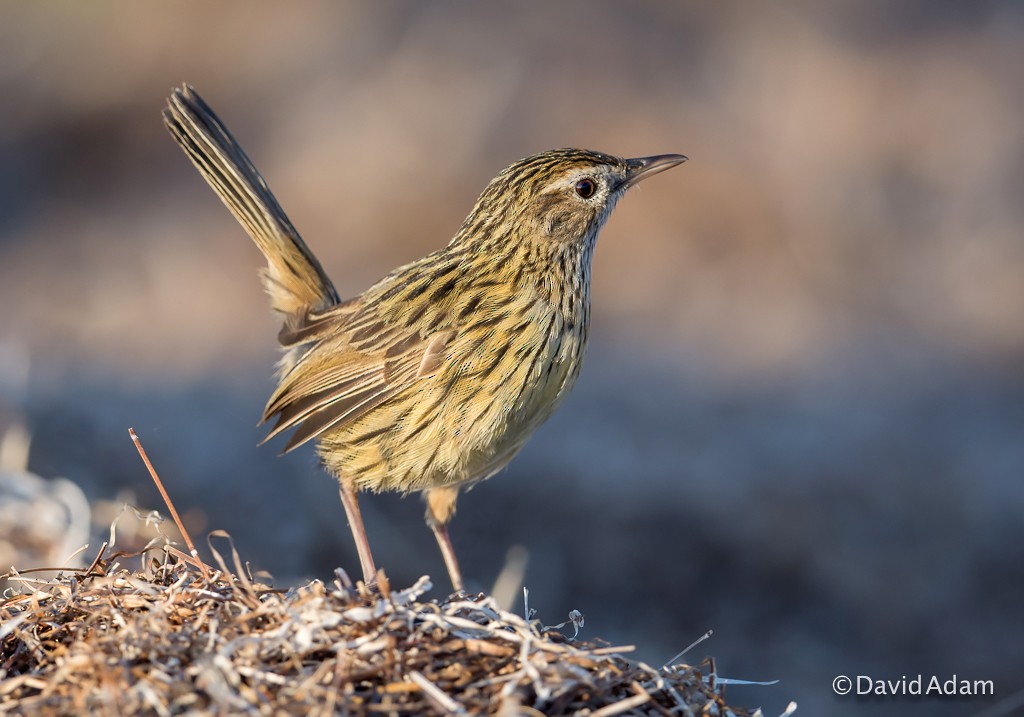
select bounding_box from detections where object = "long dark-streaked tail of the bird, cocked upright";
[164,85,339,319]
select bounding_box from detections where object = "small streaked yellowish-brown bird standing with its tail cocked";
[163,84,687,592]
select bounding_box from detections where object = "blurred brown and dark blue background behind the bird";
[0,0,1024,715]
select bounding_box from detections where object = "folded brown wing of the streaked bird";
[263,303,457,453]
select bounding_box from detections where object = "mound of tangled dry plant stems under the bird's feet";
[0,534,770,717]
